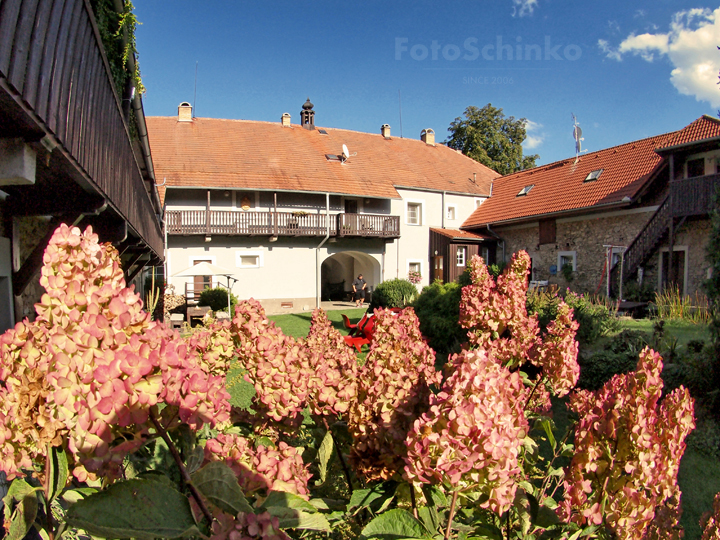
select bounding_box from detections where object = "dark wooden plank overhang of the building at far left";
[0,0,164,294]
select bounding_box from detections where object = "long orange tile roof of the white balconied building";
[147,116,499,204]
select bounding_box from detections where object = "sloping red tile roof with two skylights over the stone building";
[462,132,678,228]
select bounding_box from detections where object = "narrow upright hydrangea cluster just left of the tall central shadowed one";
[306,309,358,416]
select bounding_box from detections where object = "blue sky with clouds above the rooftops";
[135,0,720,163]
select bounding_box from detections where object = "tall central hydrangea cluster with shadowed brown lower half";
[348,308,440,481]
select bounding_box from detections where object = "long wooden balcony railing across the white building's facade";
[165,210,400,238]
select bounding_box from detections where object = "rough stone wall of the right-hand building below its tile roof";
[496,210,653,293]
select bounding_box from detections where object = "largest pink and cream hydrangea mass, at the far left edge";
[0,225,229,481]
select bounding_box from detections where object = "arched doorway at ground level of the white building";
[320,251,382,300]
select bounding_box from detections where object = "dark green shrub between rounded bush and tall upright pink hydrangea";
[413,281,467,356]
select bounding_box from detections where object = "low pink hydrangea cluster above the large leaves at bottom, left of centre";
[205,433,310,498]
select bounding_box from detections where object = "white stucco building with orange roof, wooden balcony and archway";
[148,100,498,313]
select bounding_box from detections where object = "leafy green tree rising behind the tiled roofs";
[445,103,540,175]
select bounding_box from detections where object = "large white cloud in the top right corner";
[598,8,720,107]
